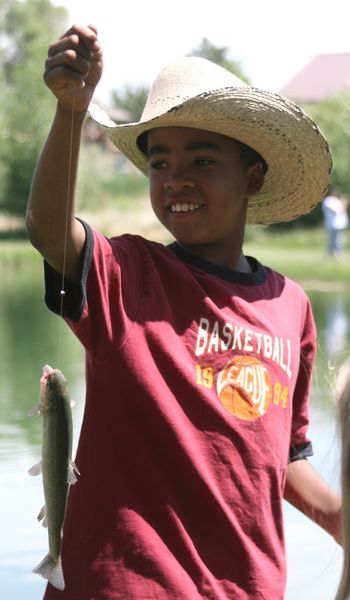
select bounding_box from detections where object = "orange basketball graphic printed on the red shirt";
[217,356,272,420]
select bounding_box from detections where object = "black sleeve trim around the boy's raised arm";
[44,219,94,323]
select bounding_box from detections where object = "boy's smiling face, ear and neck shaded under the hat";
[148,127,263,260]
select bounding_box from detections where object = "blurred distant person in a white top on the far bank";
[322,187,349,260]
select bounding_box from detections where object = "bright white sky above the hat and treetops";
[54,0,350,102]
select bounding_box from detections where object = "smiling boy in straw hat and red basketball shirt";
[27,26,340,600]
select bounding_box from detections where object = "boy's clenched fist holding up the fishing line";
[44,25,103,112]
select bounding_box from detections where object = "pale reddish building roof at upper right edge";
[279,52,350,103]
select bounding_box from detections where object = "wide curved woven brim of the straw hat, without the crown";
[90,87,332,225]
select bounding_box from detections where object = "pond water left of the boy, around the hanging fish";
[0,272,84,600]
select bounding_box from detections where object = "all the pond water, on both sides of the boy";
[0,272,350,600]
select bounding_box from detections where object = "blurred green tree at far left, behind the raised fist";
[0,0,68,215]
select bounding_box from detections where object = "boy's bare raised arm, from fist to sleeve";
[26,25,102,281]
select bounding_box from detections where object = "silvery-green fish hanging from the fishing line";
[28,365,80,590]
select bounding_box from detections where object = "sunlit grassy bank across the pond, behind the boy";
[0,209,350,289]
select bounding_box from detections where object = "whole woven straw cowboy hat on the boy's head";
[89,57,332,224]
